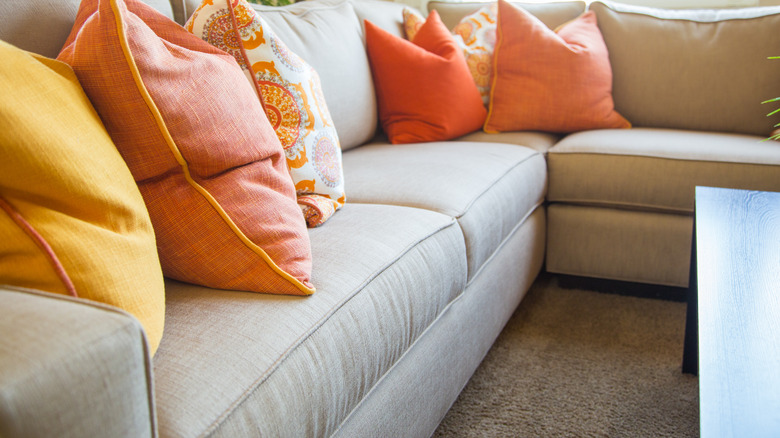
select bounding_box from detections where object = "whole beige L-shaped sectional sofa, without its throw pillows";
[0,0,780,437]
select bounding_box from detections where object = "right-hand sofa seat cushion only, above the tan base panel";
[548,128,780,214]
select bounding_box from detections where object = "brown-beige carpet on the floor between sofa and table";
[434,275,698,437]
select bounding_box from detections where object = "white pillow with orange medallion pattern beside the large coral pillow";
[185,0,346,227]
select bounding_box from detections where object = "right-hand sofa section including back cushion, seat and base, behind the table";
[546,2,780,287]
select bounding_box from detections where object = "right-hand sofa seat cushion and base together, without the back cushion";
[547,128,780,287]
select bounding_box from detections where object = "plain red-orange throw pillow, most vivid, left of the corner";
[366,11,486,144]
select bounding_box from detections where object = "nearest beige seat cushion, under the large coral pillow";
[154,204,466,437]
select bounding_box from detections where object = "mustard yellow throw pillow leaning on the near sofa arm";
[0,41,165,352]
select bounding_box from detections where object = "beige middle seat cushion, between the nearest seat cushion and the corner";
[344,142,547,279]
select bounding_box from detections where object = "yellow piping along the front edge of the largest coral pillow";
[111,0,316,295]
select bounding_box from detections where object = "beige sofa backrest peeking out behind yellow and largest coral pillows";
[0,0,176,58]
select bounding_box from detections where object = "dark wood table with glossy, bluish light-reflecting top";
[683,187,780,437]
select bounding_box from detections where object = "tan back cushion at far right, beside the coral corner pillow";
[590,2,780,137]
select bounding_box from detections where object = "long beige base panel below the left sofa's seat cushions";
[334,208,545,438]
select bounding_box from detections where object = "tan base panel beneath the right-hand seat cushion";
[545,203,693,287]
